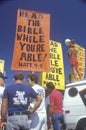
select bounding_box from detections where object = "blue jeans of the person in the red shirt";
[52,113,63,130]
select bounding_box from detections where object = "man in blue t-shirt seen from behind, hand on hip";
[1,72,42,130]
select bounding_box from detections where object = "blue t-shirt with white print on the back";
[3,83,38,113]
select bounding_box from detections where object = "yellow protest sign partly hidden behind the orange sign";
[40,40,65,90]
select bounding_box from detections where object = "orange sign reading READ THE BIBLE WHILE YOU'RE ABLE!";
[11,9,50,72]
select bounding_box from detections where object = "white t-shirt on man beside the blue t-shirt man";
[30,84,46,112]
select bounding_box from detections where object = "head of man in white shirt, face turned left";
[27,74,38,86]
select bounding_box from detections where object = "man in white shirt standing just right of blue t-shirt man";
[27,73,47,130]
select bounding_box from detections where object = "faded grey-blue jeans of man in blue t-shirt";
[6,115,29,130]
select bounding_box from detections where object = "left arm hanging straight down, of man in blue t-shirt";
[1,99,8,122]
